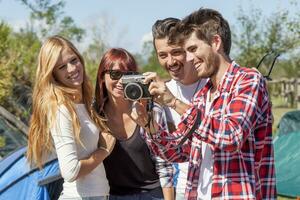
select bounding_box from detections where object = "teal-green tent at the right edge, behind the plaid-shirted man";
[274,111,300,197]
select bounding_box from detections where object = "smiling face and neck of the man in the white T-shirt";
[154,38,198,84]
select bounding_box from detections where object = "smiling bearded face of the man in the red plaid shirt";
[184,32,219,78]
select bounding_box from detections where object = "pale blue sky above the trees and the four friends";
[0,0,293,53]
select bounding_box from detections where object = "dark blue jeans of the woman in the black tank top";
[109,188,164,200]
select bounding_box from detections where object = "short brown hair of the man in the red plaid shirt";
[180,8,231,55]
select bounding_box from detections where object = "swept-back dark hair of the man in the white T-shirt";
[152,17,180,48]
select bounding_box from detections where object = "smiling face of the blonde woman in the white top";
[53,48,84,89]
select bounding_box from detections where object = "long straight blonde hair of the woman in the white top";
[27,36,102,168]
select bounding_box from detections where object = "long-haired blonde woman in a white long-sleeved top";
[27,36,115,200]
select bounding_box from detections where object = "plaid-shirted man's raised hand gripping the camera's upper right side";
[143,72,175,107]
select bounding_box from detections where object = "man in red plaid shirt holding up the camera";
[144,8,276,200]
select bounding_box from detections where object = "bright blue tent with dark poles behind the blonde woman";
[0,147,63,200]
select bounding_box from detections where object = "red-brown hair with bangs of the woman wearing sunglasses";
[95,48,137,116]
